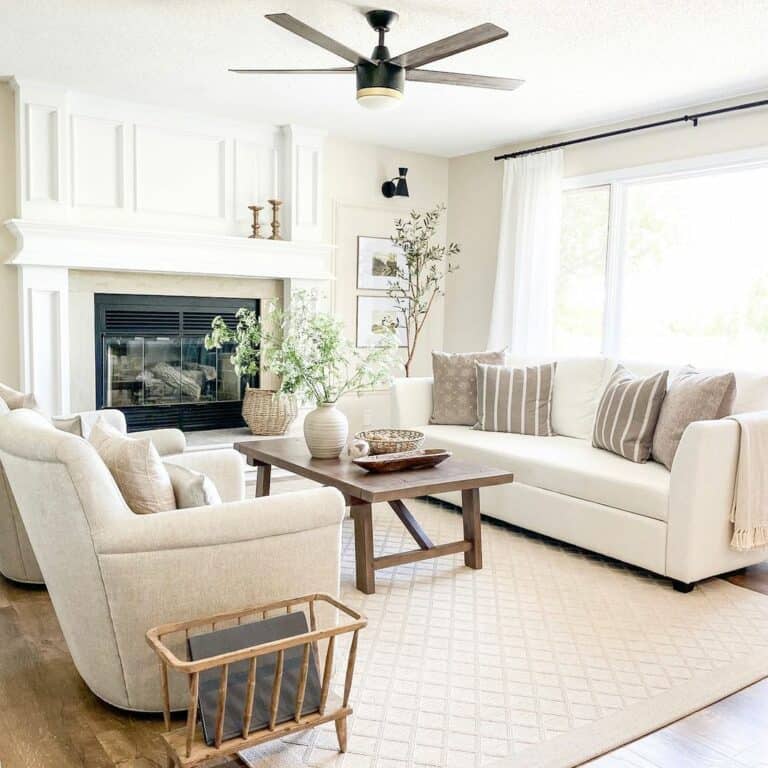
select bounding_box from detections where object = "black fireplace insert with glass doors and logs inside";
[95,293,259,432]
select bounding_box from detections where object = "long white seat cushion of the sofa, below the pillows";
[419,425,671,521]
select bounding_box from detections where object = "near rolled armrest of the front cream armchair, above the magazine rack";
[94,488,344,556]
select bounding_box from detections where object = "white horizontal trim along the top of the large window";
[563,145,768,190]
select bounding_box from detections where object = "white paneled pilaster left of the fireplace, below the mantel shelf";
[19,267,69,414]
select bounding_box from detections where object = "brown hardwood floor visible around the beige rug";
[0,544,768,768]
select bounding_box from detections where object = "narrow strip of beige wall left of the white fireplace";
[0,82,21,387]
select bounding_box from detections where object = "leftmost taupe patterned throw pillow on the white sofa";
[429,349,504,427]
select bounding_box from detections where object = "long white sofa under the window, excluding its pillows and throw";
[392,357,768,591]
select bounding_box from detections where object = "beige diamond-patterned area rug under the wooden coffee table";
[243,502,768,768]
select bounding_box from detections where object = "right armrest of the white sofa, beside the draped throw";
[666,419,765,583]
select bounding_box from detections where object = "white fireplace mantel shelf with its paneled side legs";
[6,219,333,414]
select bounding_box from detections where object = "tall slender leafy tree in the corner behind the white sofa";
[377,205,461,376]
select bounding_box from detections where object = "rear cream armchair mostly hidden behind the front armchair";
[0,408,187,584]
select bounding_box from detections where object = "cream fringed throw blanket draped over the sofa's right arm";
[729,411,768,551]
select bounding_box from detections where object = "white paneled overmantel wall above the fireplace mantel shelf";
[14,81,323,237]
